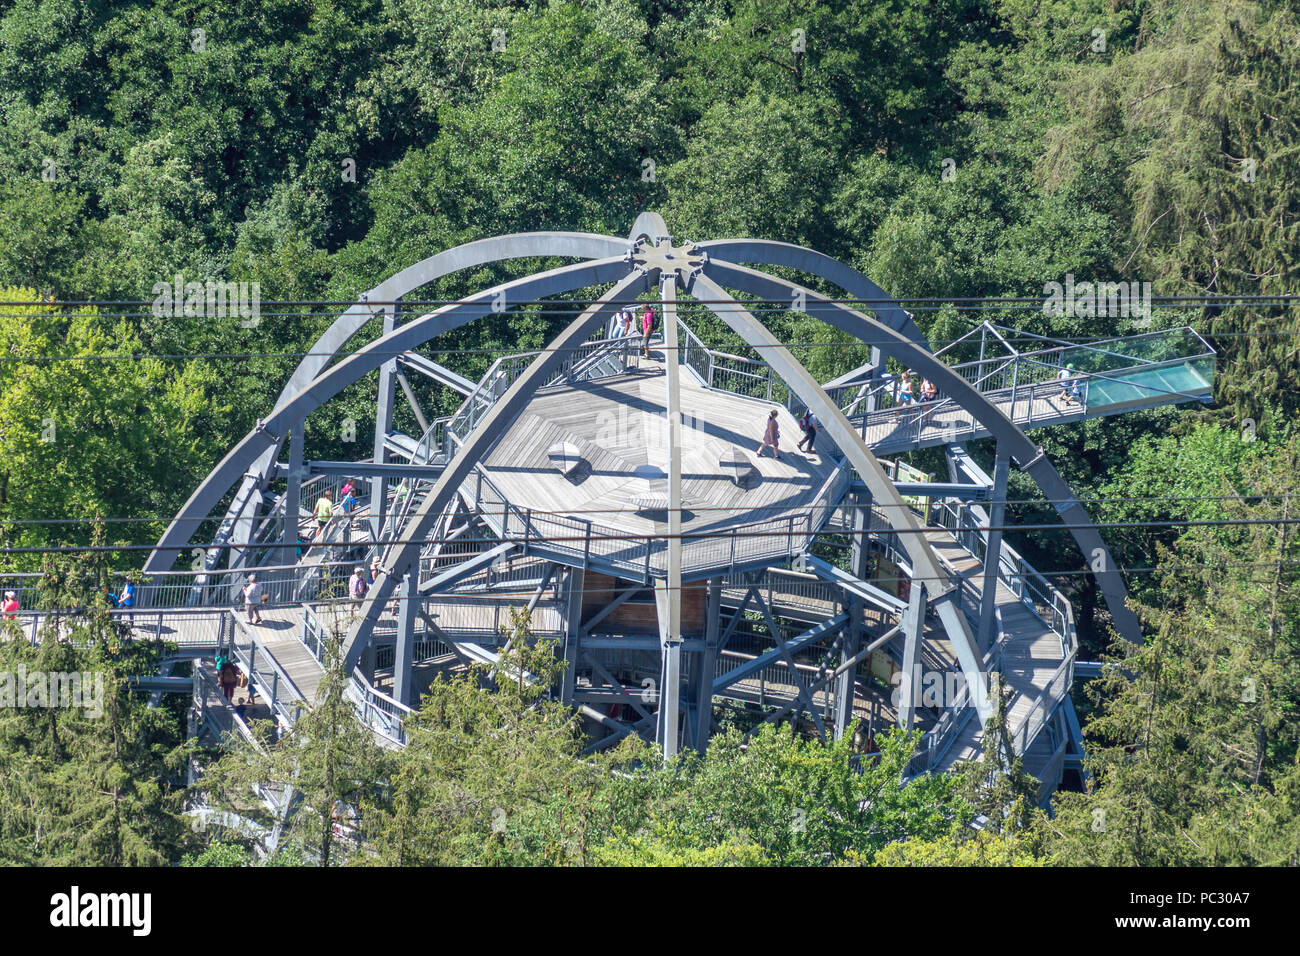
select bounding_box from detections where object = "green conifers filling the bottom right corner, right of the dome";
[1049,440,1300,865]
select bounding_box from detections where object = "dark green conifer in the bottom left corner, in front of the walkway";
[0,533,194,866]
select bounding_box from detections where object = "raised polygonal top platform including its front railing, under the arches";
[462,359,849,578]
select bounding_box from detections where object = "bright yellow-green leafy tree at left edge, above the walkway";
[0,287,220,570]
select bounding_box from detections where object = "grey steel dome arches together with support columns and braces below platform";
[144,212,1170,785]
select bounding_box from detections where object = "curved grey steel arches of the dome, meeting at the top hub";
[146,212,1139,750]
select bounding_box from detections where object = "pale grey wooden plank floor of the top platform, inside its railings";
[465,359,835,566]
